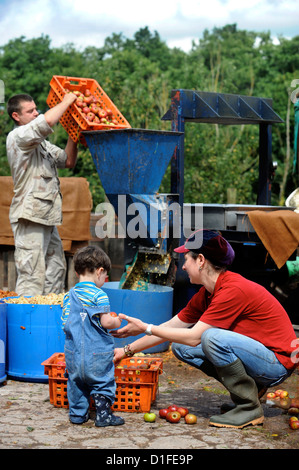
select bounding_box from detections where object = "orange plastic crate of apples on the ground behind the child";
[42,353,163,413]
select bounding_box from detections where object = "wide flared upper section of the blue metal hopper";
[84,129,182,195]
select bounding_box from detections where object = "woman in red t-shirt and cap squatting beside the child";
[114,230,299,428]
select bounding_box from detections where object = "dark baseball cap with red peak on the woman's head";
[174,230,235,266]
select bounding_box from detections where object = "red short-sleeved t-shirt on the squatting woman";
[178,271,299,369]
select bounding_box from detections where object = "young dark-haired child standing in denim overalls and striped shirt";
[62,246,124,426]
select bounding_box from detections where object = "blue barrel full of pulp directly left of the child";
[6,304,65,382]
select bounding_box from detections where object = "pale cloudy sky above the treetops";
[0,0,299,52]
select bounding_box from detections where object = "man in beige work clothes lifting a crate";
[6,93,77,296]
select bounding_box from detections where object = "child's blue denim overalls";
[64,289,116,424]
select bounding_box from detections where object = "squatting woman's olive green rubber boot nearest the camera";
[209,359,264,428]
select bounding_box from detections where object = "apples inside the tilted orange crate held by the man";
[64,88,118,126]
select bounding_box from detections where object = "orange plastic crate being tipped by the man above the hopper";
[47,75,131,145]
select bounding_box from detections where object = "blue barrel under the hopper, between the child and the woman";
[102,282,173,354]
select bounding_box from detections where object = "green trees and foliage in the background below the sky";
[0,24,299,208]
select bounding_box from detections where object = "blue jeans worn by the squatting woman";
[172,328,292,387]
